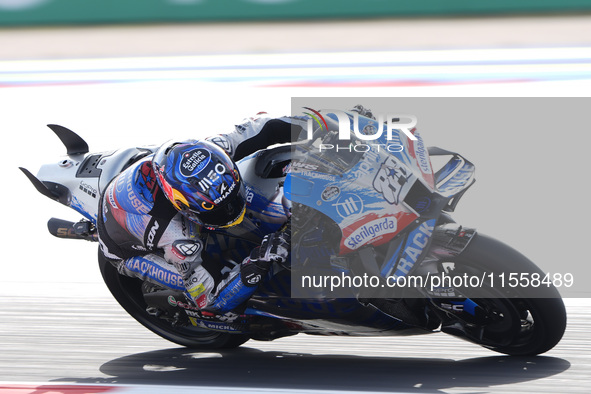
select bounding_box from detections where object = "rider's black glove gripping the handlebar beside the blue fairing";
[240,231,290,286]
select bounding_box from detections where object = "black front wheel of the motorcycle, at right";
[442,234,566,356]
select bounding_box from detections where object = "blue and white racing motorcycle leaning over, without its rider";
[21,112,566,356]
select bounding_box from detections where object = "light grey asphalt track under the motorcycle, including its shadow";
[0,296,591,393]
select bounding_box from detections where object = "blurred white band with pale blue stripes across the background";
[0,47,591,86]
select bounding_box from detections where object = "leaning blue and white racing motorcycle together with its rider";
[20,103,572,356]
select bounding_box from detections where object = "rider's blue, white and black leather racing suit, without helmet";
[97,114,303,314]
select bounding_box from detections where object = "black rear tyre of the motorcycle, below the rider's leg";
[99,250,250,349]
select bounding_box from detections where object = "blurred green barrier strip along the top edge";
[0,0,591,26]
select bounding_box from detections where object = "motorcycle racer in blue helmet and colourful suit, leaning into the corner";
[97,113,303,314]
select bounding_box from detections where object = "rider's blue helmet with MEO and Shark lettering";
[152,140,246,228]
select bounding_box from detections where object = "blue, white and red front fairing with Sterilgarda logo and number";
[286,111,474,254]
